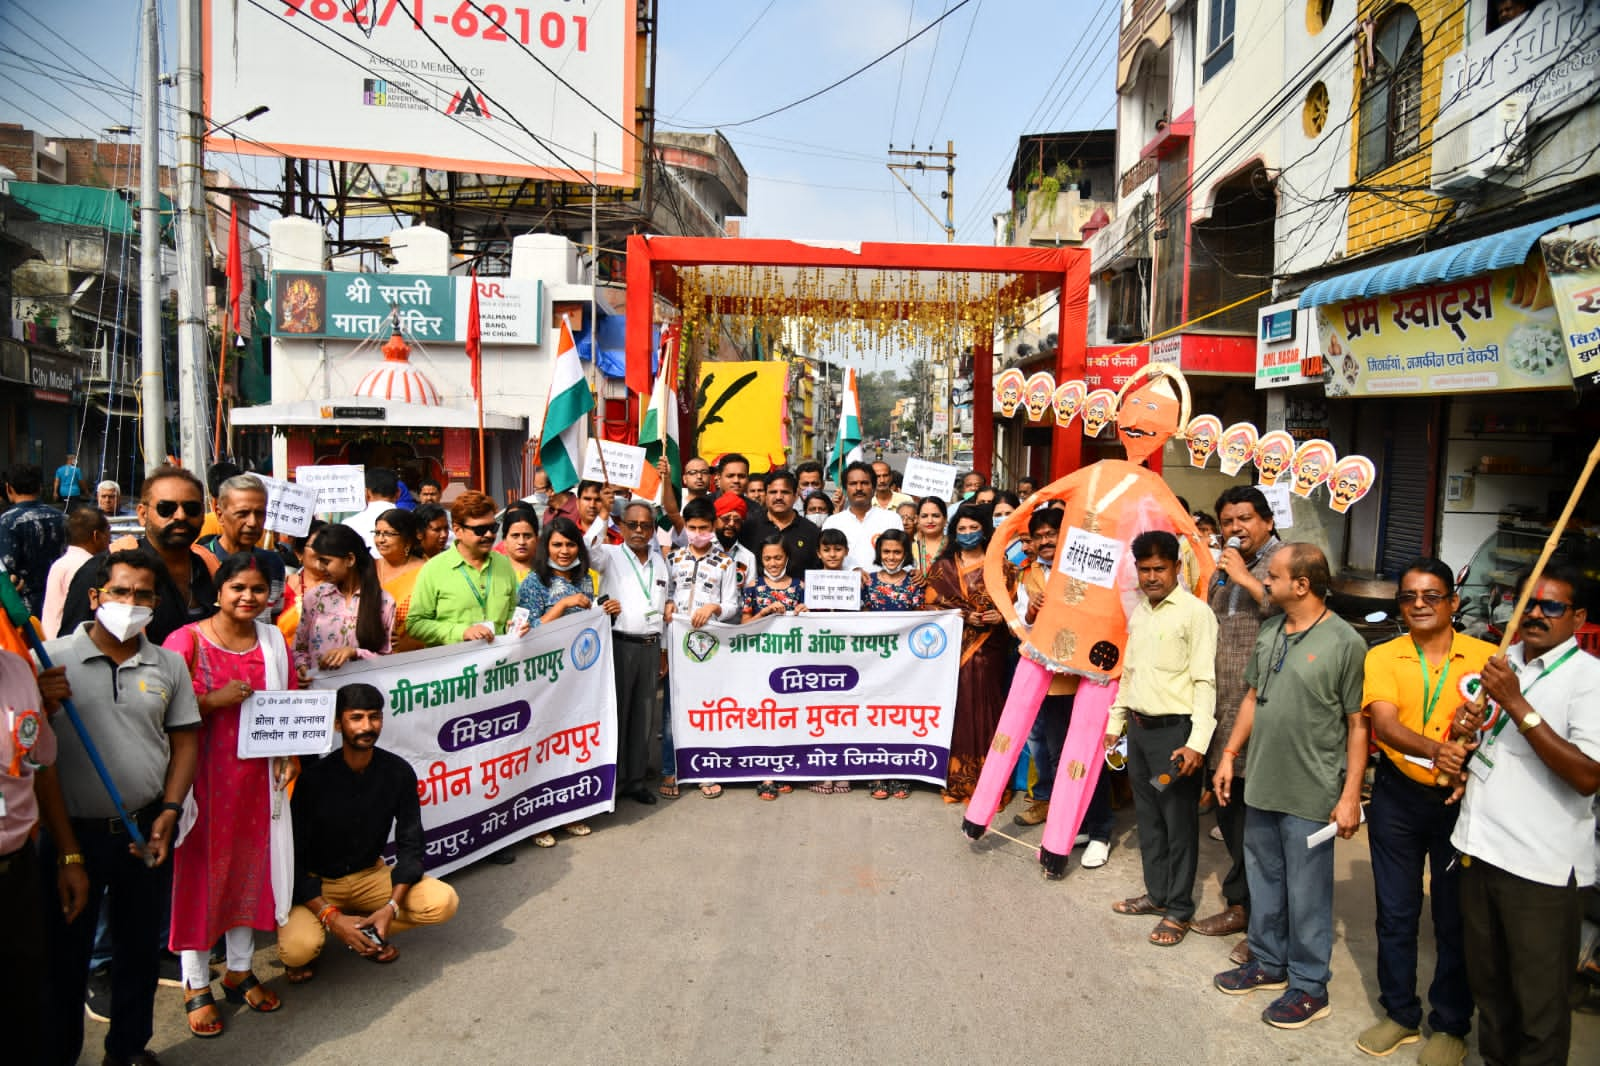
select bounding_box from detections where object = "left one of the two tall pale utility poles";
[136,0,166,470]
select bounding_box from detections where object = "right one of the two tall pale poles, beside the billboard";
[178,0,211,477]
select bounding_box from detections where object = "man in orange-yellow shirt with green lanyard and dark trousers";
[1355,559,1494,1066]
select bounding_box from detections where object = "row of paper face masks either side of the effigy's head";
[995,367,1378,514]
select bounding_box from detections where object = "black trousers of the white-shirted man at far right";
[1461,856,1581,1066]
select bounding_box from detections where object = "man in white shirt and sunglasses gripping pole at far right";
[1450,563,1600,1063]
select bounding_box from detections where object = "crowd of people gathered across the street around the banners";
[0,455,1600,1064]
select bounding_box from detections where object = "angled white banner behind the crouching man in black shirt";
[312,610,616,874]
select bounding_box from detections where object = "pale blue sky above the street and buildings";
[0,0,1122,361]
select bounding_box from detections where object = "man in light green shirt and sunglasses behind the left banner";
[405,491,517,647]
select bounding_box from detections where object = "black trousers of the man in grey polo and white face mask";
[35,805,173,1066]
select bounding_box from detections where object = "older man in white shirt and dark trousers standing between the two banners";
[586,499,672,807]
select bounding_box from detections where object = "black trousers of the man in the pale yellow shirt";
[1128,714,1203,922]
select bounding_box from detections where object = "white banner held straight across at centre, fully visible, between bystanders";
[667,611,962,784]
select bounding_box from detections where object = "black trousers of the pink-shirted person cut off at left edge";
[0,842,48,1063]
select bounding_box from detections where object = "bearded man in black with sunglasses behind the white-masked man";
[61,466,216,643]
